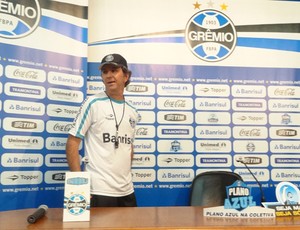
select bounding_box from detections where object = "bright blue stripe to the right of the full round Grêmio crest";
[237,38,300,52]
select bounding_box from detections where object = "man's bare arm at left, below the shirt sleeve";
[66,135,81,172]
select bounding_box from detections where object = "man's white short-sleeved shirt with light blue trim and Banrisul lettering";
[69,92,140,197]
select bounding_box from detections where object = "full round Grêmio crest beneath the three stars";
[185,10,236,62]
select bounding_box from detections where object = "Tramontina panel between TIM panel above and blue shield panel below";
[157,125,194,138]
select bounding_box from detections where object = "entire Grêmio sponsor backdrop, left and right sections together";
[0,0,300,210]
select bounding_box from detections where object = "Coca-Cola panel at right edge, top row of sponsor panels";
[268,86,300,98]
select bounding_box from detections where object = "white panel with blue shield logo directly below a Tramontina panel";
[157,140,194,153]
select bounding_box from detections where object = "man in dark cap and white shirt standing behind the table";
[66,54,139,207]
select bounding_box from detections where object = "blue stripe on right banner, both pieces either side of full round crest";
[89,36,300,52]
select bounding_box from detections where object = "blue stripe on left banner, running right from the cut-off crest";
[40,16,88,43]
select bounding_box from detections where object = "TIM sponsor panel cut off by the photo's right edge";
[269,127,300,139]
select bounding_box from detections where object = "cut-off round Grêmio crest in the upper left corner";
[0,0,41,38]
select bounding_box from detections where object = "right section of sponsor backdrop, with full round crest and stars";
[87,0,300,206]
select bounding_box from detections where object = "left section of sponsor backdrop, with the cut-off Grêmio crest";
[0,0,88,211]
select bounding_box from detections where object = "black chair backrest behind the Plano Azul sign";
[190,171,243,206]
